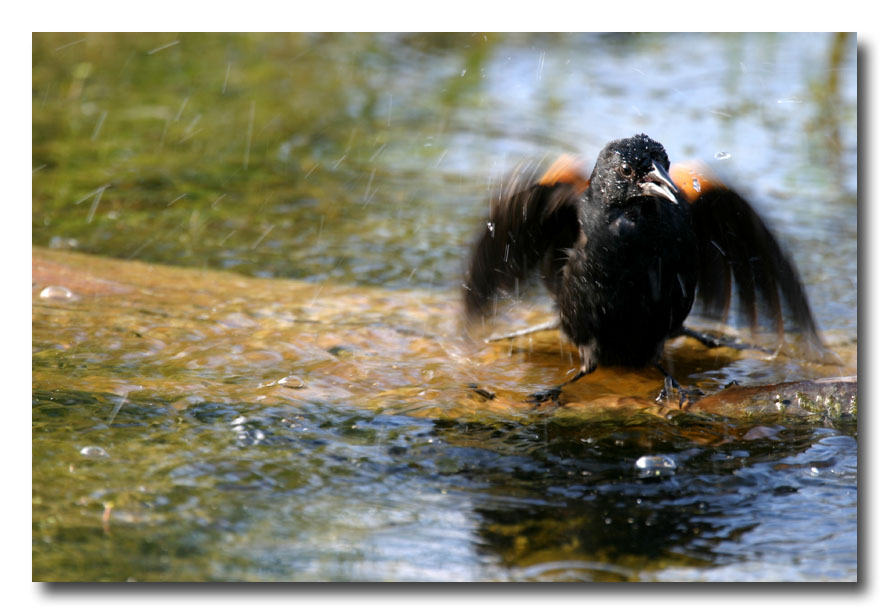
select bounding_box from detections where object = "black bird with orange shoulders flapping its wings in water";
[464,134,824,398]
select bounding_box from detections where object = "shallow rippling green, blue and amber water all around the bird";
[32,34,857,581]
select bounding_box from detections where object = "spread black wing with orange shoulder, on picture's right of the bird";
[670,164,825,357]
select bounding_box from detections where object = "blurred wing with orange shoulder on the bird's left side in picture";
[463,156,587,320]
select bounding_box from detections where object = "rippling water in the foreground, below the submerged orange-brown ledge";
[34,384,856,580]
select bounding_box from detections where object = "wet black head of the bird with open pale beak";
[590,134,679,206]
